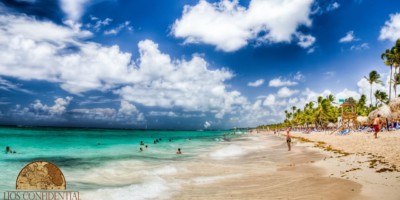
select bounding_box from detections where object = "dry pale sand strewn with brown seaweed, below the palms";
[258,131,400,200]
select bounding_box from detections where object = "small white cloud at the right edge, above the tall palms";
[379,13,400,42]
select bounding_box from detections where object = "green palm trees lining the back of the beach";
[257,39,400,129]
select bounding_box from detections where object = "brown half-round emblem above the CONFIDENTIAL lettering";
[16,161,67,190]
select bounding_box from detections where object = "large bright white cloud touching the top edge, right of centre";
[172,0,315,52]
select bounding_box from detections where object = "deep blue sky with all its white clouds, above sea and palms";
[0,0,400,129]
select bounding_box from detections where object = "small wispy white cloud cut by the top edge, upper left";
[60,0,90,21]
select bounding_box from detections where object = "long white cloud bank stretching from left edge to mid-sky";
[0,15,248,121]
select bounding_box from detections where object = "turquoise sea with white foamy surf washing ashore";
[0,127,247,199]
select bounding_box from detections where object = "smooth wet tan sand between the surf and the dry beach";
[171,136,367,200]
